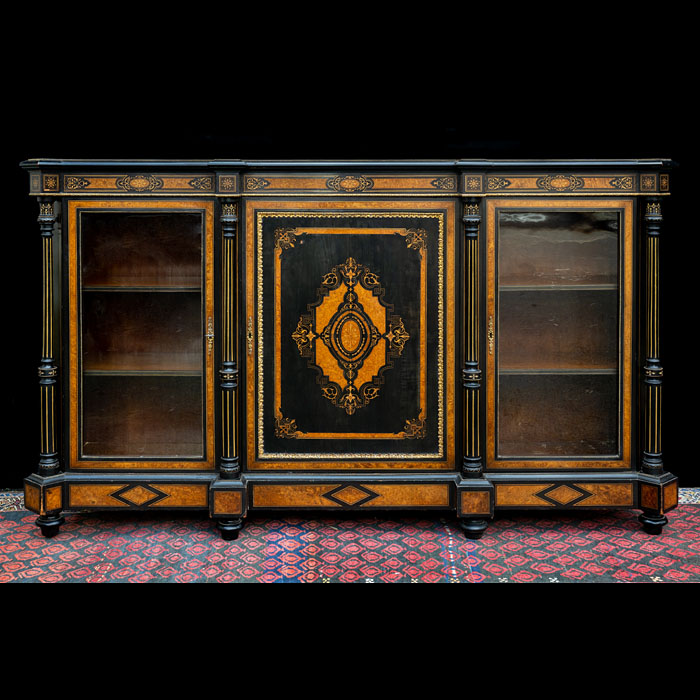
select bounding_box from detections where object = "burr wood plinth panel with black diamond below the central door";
[251,483,450,508]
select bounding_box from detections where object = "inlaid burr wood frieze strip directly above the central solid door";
[243,173,457,195]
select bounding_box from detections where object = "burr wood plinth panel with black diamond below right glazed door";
[495,482,634,508]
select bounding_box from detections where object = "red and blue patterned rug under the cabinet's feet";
[0,489,700,583]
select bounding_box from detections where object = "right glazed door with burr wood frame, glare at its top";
[486,198,633,470]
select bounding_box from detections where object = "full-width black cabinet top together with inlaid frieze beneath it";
[20,158,675,197]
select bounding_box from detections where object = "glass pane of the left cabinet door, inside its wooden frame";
[80,211,205,459]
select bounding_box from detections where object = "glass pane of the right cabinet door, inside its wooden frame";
[496,211,620,459]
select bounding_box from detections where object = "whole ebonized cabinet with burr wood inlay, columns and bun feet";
[21,159,677,538]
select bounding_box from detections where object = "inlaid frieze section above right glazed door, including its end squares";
[461,171,670,196]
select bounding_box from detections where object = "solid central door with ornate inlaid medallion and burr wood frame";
[245,200,455,470]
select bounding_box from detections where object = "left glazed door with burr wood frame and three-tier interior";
[68,200,214,470]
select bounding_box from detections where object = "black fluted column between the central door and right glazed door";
[462,199,483,479]
